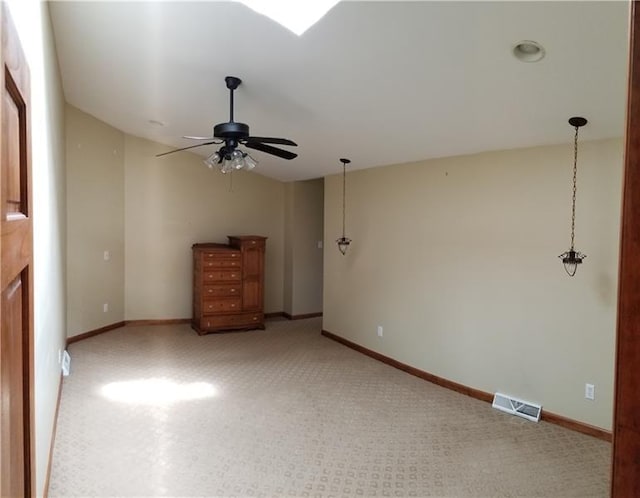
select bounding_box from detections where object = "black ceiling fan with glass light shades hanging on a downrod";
[156,76,298,173]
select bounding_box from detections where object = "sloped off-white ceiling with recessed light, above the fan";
[50,1,629,181]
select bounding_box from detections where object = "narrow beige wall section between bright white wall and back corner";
[66,105,124,336]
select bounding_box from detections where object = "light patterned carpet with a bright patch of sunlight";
[49,319,611,497]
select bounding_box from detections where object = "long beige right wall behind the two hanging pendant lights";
[323,139,623,429]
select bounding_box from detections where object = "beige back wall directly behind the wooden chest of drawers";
[125,136,285,320]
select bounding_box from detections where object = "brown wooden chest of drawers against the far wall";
[191,235,266,334]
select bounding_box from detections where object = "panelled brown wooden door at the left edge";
[0,2,34,496]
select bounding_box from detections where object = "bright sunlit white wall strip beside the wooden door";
[8,0,66,496]
